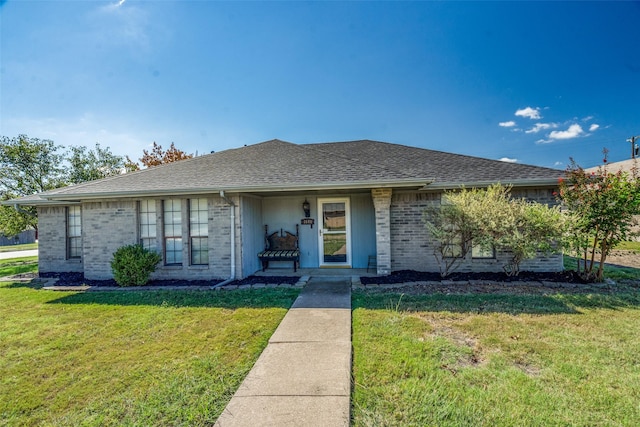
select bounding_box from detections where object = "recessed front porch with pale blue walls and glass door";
[236,188,391,277]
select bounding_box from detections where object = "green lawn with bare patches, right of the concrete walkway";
[352,288,640,426]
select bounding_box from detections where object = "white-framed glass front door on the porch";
[318,198,351,267]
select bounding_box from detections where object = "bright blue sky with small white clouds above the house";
[0,0,640,168]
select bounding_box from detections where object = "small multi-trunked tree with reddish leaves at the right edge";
[559,159,640,281]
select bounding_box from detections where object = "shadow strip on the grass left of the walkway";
[48,288,300,309]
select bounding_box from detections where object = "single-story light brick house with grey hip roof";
[7,140,562,279]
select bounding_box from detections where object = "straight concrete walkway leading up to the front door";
[215,277,351,427]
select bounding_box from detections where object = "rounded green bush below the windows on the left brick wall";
[111,245,162,286]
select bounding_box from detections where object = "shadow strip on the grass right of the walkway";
[351,291,640,314]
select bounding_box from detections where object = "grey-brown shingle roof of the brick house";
[10,140,562,202]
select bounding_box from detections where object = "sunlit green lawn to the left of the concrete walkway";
[0,282,298,426]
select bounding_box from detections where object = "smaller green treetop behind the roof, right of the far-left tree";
[67,144,125,184]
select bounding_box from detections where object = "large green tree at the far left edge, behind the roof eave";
[0,135,65,236]
